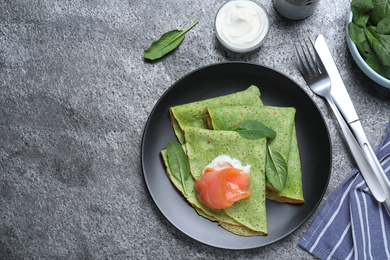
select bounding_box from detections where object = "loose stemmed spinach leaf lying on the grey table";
[144,21,198,60]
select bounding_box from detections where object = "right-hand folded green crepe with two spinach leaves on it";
[204,106,304,203]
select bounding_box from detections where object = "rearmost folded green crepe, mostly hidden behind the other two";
[169,85,263,144]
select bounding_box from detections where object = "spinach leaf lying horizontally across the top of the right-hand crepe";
[235,120,276,139]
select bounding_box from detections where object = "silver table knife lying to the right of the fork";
[314,34,390,215]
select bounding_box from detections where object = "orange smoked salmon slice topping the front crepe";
[195,168,250,209]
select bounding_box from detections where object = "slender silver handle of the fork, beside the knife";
[326,97,390,202]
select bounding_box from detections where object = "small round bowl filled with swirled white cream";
[215,0,270,52]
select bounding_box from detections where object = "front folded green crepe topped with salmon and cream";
[161,127,267,236]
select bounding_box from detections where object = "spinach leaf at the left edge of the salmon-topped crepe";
[167,141,191,195]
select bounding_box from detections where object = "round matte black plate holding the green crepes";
[141,62,331,249]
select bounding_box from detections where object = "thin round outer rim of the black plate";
[140,61,333,250]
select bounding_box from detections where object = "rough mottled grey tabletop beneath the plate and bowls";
[0,0,390,259]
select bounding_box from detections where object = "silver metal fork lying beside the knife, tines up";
[294,39,390,212]
